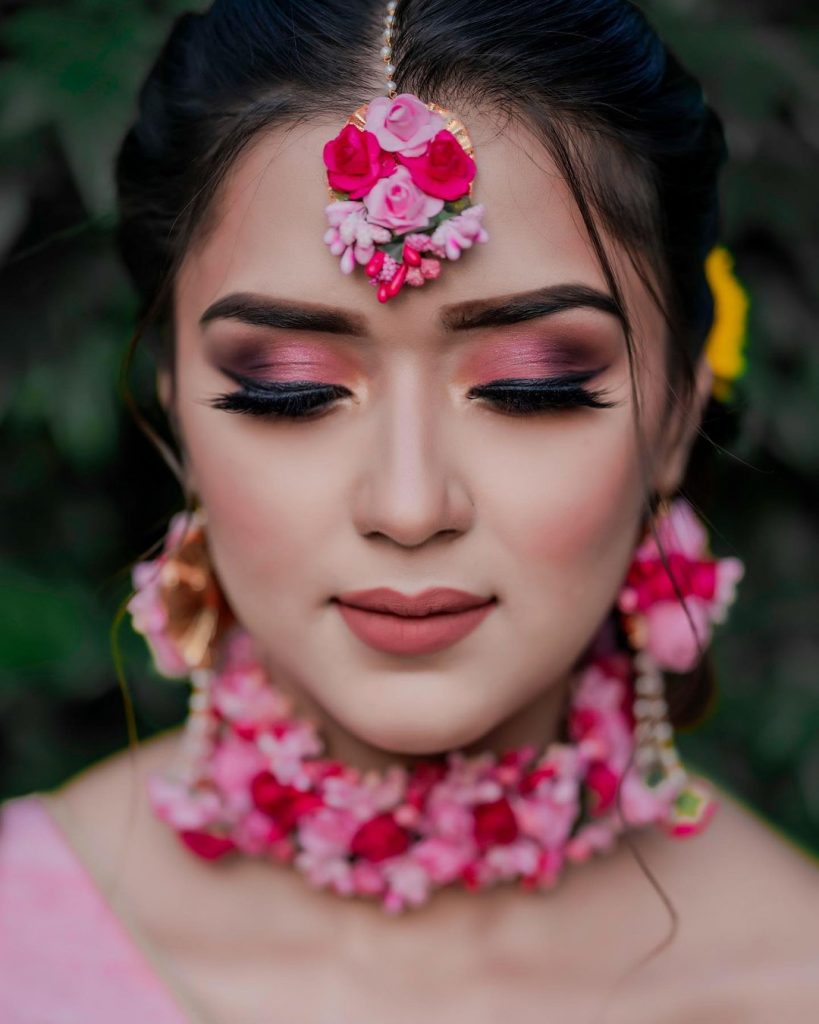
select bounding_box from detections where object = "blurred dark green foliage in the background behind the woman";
[0,0,819,850]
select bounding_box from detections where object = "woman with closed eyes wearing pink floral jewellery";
[0,0,819,1024]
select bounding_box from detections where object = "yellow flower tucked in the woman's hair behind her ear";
[705,246,748,401]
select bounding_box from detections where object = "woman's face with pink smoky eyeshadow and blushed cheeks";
[169,116,708,754]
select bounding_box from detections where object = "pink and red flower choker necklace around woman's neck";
[148,627,718,913]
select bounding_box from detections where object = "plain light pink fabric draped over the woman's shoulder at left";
[0,793,187,1024]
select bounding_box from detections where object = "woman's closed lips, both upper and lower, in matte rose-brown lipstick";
[335,587,498,654]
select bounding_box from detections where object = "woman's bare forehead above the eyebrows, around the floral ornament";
[177,112,656,339]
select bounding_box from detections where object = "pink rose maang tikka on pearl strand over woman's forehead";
[324,0,488,302]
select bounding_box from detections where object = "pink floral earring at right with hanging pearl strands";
[616,498,744,835]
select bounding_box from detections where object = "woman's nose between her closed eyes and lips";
[355,372,474,548]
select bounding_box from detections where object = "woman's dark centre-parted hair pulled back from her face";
[117,0,726,970]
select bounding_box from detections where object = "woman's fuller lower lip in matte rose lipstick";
[336,601,497,654]
